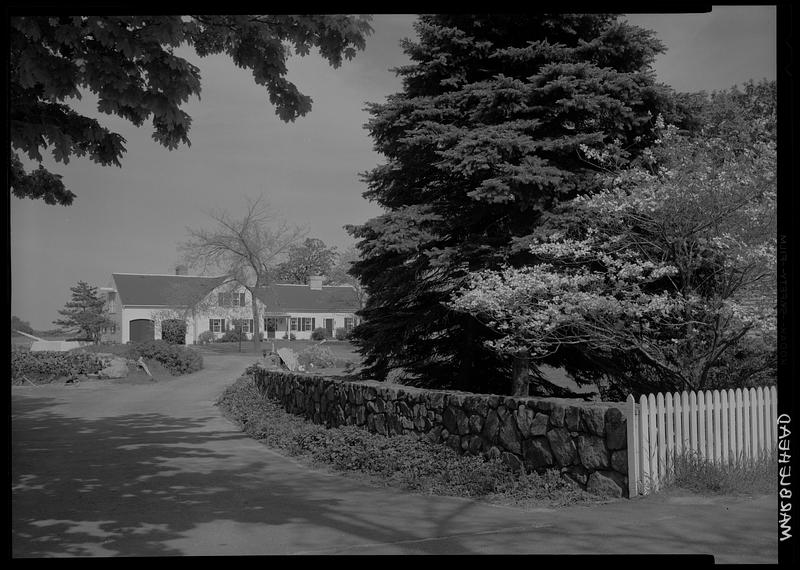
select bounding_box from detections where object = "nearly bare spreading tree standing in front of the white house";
[179,196,306,351]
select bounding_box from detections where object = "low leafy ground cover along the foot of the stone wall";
[217,376,597,506]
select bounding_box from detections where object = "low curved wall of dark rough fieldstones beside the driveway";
[255,370,628,496]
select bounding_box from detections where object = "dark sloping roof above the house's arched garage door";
[112,273,227,307]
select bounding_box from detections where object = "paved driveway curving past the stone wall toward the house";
[11,355,778,563]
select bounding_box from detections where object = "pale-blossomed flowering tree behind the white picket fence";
[450,113,776,397]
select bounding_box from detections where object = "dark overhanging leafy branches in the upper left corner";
[8,14,372,206]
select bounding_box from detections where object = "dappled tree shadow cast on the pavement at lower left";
[11,390,482,557]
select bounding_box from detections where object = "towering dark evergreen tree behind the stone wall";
[349,14,667,390]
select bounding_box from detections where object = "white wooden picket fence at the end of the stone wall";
[625,387,778,497]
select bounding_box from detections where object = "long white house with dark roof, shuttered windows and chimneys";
[100,266,359,344]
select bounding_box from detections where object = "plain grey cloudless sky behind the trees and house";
[10,6,776,330]
